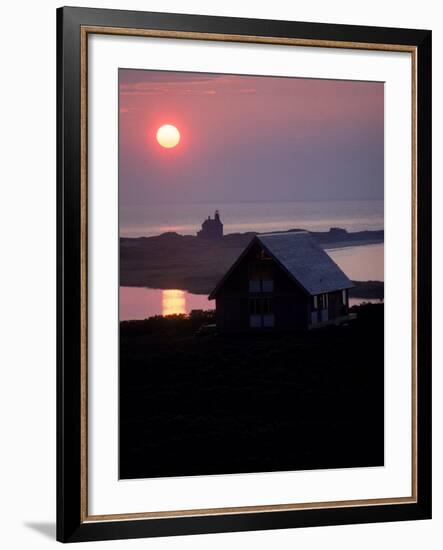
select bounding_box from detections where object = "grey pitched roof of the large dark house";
[209,231,354,299]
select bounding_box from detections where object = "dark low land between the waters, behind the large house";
[120,228,384,298]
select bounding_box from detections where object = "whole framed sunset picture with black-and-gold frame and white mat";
[57,8,431,542]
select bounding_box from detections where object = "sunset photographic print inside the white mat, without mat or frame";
[119,69,384,479]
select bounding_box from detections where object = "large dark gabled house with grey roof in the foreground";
[209,231,353,332]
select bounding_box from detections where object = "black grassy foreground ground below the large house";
[120,305,384,478]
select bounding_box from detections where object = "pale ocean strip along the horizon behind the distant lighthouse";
[120,200,383,237]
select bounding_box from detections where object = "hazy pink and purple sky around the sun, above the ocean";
[119,69,384,213]
